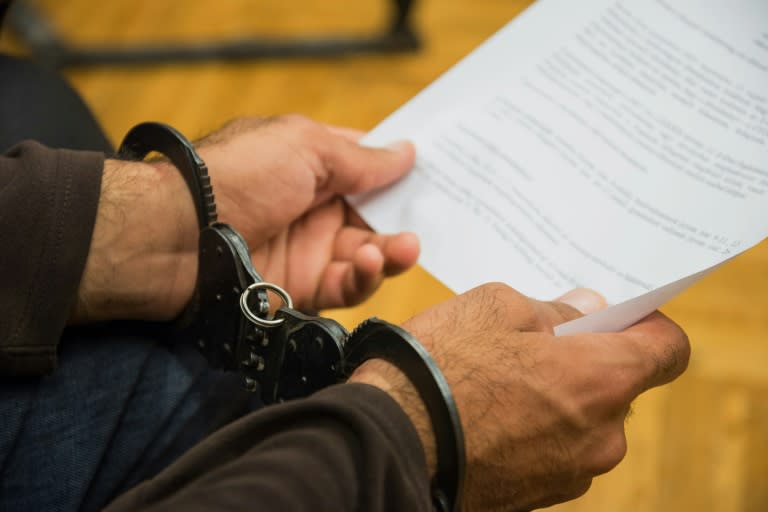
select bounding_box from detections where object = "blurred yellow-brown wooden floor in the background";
[2,0,768,512]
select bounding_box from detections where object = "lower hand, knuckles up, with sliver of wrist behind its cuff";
[350,284,690,511]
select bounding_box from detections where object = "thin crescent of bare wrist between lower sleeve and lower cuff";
[348,359,437,478]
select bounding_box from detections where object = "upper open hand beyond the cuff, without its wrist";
[195,115,418,309]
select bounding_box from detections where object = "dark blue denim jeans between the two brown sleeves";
[0,323,259,512]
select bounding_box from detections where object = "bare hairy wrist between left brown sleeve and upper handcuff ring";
[71,160,198,322]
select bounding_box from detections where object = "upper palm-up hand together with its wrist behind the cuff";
[73,116,419,322]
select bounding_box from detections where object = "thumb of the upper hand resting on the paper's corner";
[318,136,416,197]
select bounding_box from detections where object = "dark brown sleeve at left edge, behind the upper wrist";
[0,142,104,376]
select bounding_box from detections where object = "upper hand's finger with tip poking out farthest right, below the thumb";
[333,227,419,276]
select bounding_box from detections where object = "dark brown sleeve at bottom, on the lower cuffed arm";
[105,384,431,512]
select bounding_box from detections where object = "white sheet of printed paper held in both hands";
[352,0,768,333]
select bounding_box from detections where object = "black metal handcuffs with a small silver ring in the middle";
[118,123,465,512]
